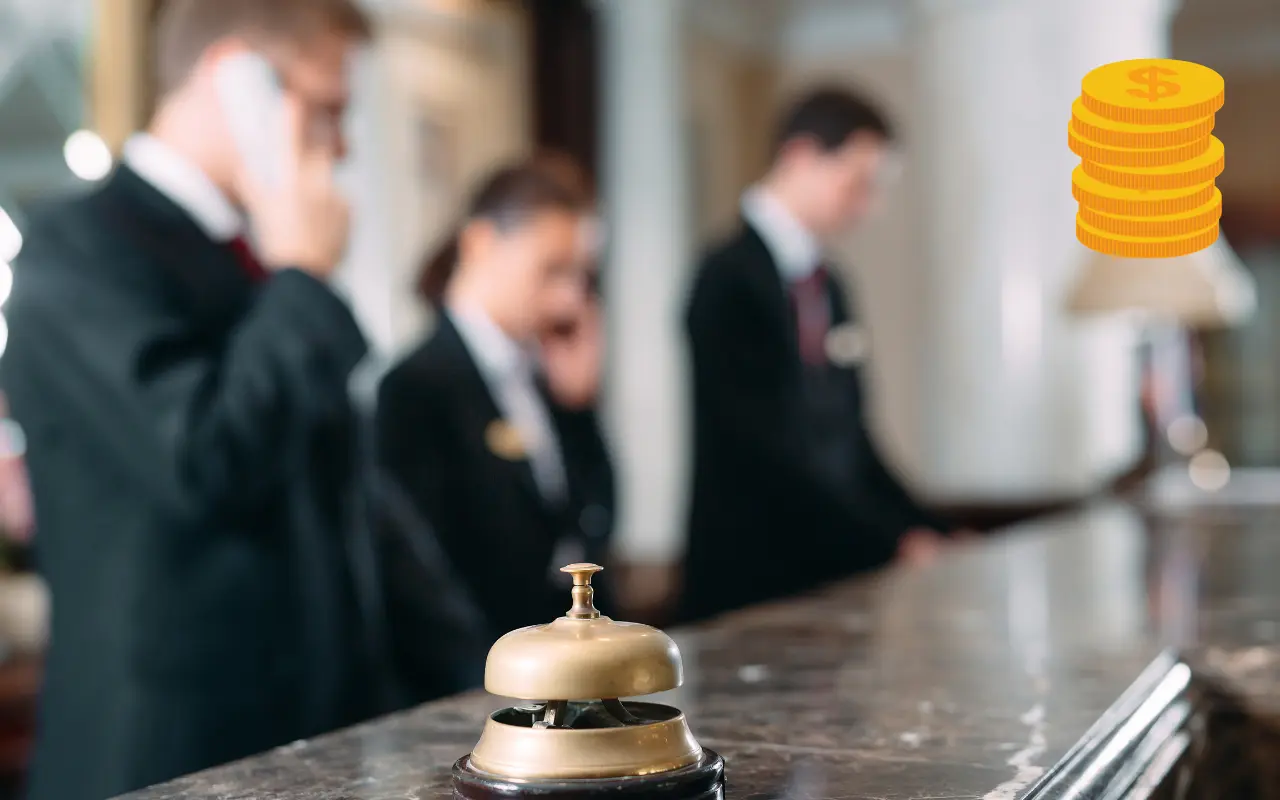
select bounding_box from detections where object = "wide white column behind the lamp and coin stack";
[911,0,1170,502]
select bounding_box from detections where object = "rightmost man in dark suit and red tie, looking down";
[682,90,957,618]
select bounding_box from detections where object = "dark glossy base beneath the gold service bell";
[453,749,724,800]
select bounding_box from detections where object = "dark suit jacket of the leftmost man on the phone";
[0,168,371,800]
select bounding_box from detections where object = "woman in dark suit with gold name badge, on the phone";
[378,163,613,637]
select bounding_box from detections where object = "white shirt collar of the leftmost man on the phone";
[124,133,244,242]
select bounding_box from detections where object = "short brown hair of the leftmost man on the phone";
[154,0,372,96]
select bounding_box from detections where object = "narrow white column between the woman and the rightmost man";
[598,0,692,562]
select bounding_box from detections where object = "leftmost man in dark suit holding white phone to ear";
[3,0,389,800]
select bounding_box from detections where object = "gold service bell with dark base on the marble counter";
[453,563,724,800]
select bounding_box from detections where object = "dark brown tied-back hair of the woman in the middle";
[417,152,593,308]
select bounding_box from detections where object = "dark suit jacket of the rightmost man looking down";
[682,225,936,618]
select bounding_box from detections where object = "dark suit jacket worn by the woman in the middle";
[378,315,613,636]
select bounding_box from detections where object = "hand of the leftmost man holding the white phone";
[236,96,351,279]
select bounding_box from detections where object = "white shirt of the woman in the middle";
[449,307,567,501]
